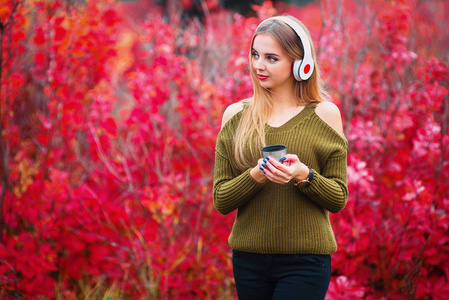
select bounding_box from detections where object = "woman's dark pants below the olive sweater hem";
[232,250,331,300]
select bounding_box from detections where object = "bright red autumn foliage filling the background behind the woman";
[0,0,449,299]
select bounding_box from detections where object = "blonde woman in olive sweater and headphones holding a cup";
[214,16,348,300]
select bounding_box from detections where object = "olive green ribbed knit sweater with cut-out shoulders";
[213,104,348,254]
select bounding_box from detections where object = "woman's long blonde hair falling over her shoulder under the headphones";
[234,16,327,170]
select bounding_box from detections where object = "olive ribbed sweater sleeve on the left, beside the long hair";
[213,134,264,215]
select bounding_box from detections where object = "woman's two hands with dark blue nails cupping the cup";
[262,154,309,184]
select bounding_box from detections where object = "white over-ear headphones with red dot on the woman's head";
[257,16,315,81]
